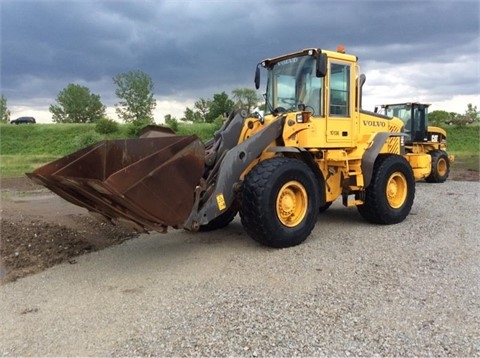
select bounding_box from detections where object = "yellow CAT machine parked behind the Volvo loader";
[375,102,455,183]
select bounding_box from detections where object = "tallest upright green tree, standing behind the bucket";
[113,71,157,124]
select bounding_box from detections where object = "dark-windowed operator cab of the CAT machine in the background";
[382,102,430,144]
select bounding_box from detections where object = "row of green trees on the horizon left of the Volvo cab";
[0,71,261,126]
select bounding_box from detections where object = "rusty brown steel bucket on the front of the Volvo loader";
[27,135,205,231]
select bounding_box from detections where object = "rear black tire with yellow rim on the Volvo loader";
[357,154,415,225]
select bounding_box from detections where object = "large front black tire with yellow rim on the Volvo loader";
[240,157,320,248]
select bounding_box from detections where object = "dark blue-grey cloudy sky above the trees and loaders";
[0,0,480,123]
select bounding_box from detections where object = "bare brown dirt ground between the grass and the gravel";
[0,166,480,283]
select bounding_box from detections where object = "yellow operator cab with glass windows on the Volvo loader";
[255,48,360,148]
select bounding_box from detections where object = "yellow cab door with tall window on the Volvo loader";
[326,60,355,147]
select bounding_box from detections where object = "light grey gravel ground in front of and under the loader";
[0,181,480,357]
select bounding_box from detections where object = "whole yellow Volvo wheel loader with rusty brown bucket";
[28,48,430,247]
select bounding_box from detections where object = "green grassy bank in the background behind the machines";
[0,123,480,177]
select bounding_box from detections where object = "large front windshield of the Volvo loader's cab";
[266,56,323,116]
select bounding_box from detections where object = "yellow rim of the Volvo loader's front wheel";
[277,180,308,227]
